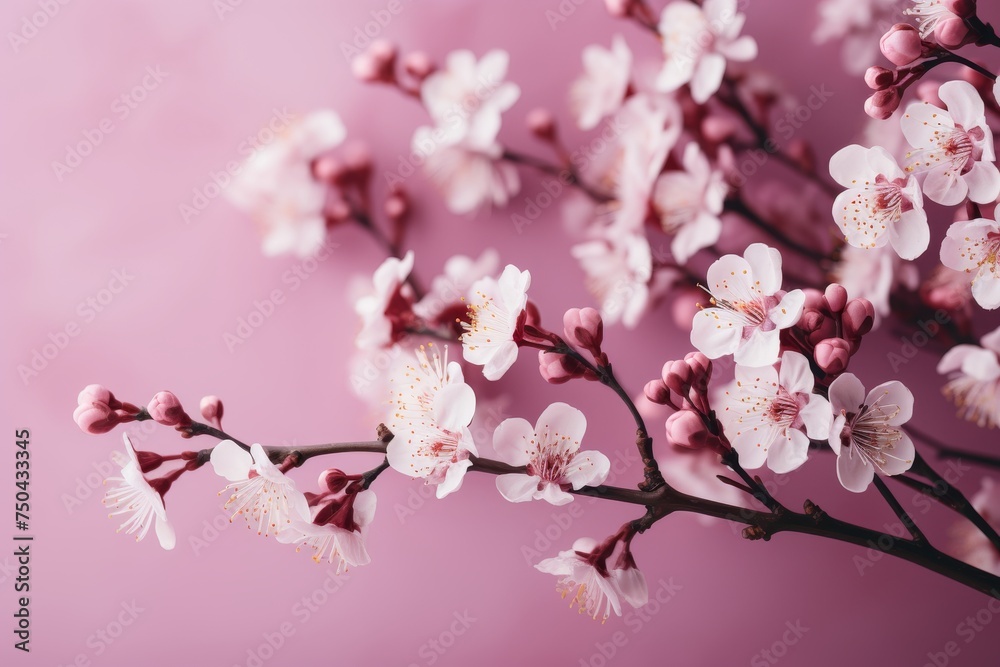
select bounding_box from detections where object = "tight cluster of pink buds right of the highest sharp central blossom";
[782,283,875,379]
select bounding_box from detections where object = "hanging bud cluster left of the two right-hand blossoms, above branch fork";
[644,352,730,454]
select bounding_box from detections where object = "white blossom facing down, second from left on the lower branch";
[210,440,309,536]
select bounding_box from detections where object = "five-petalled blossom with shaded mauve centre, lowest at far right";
[829,373,915,493]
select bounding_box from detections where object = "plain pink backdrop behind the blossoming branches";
[0,0,1000,667]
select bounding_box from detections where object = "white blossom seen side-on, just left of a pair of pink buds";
[462,264,531,380]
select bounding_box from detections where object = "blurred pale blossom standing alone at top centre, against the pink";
[570,35,632,130]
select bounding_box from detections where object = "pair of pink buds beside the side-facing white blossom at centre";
[526,303,608,384]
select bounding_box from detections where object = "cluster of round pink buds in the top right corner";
[865,0,981,120]
